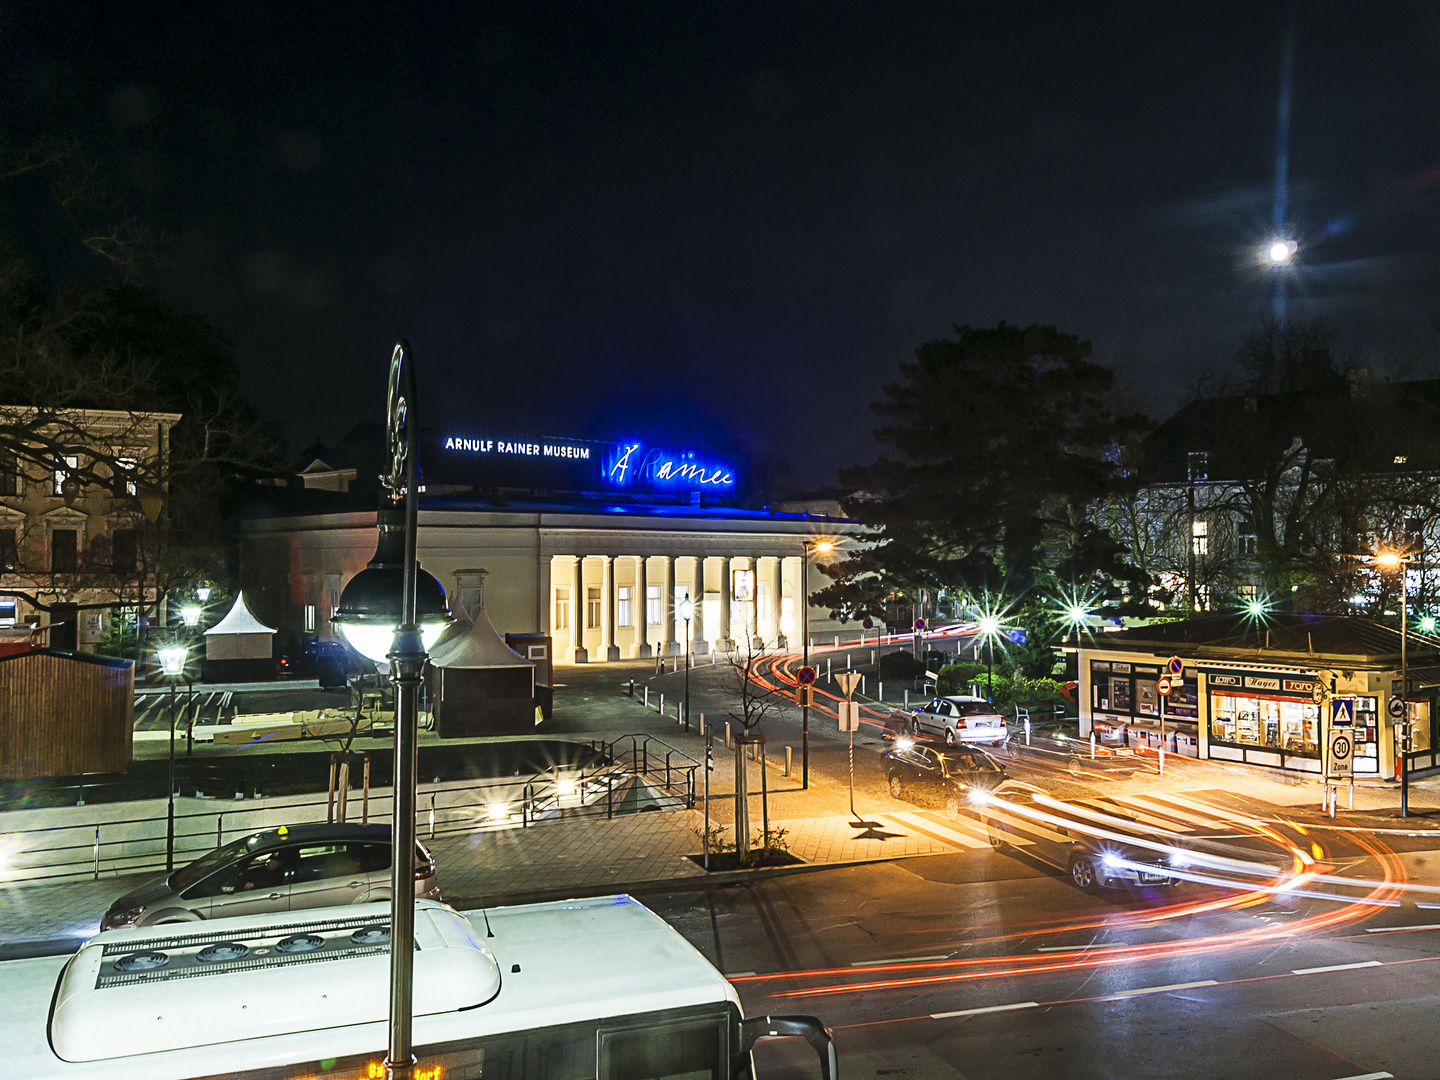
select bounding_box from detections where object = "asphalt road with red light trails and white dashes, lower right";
[645,812,1440,1080]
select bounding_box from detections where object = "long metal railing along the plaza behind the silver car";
[0,734,700,884]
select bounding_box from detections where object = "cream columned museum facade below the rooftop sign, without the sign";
[240,500,863,664]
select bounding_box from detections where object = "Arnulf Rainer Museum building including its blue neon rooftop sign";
[239,425,864,662]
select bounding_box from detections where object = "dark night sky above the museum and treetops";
[0,0,1440,484]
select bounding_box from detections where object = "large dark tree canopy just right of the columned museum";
[816,323,1149,618]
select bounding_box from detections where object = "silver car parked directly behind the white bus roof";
[99,825,441,930]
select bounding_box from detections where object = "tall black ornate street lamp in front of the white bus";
[334,340,451,1080]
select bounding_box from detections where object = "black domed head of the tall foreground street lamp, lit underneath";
[333,507,451,664]
